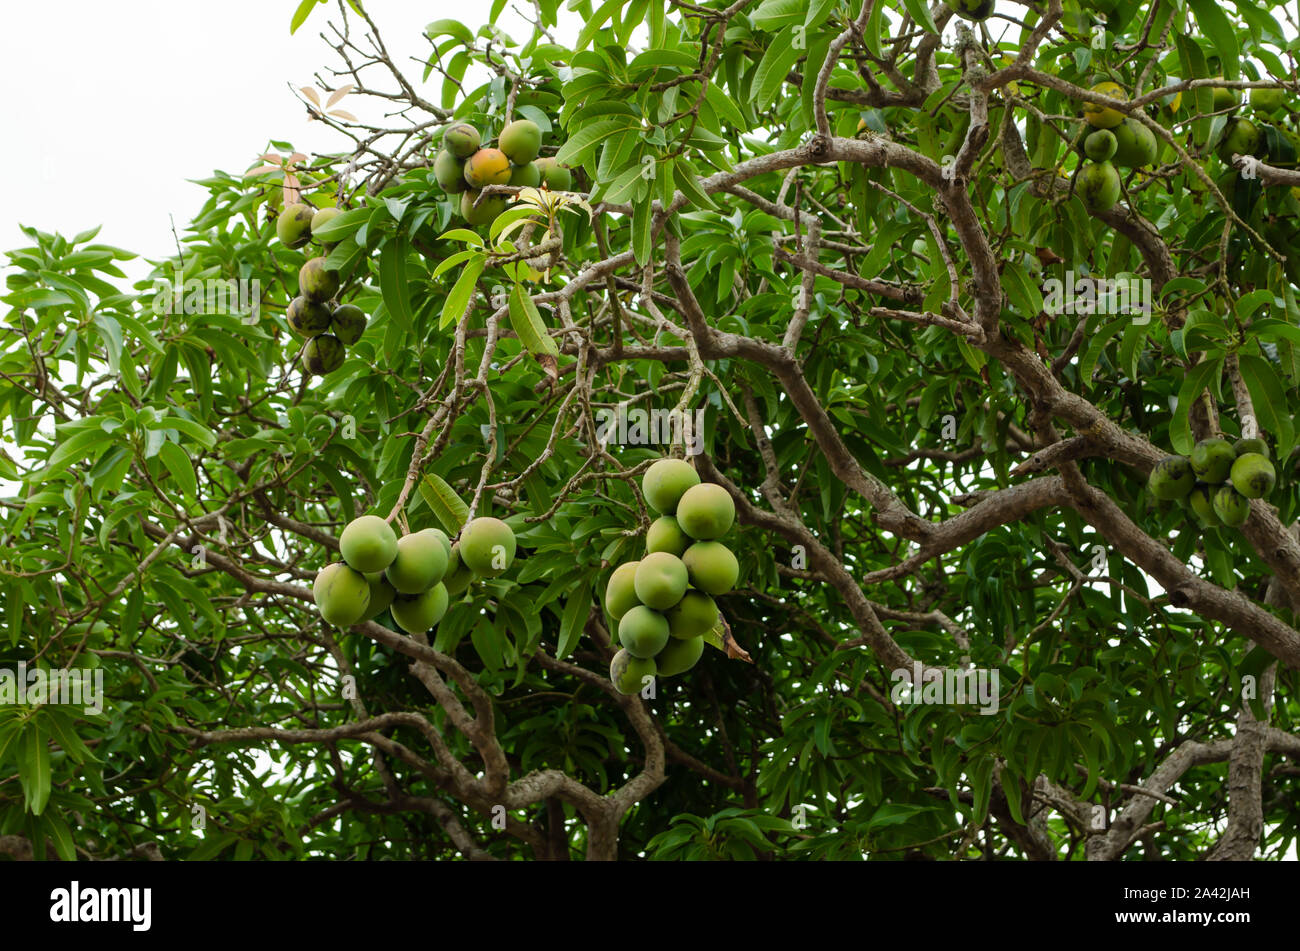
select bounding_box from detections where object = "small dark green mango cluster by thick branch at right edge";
[1147,438,1277,527]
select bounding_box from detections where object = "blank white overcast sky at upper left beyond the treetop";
[0,0,538,268]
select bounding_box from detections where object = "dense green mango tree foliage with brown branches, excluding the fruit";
[0,0,1300,860]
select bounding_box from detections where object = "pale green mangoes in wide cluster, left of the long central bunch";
[312,516,516,634]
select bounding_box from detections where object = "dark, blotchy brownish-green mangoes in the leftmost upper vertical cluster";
[276,203,365,377]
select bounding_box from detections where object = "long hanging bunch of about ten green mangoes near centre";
[605,459,740,694]
